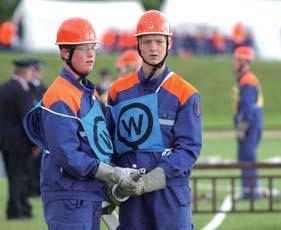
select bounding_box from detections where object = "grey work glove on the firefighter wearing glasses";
[95,162,138,186]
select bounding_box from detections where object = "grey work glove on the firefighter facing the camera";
[119,167,166,196]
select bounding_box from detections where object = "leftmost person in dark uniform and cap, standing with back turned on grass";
[0,60,37,219]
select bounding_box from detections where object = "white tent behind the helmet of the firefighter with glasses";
[13,0,143,52]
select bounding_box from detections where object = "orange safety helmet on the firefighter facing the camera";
[135,10,172,37]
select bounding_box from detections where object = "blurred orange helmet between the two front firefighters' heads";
[116,49,141,68]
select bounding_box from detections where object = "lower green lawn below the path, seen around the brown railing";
[0,137,281,230]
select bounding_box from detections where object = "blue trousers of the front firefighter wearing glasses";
[43,200,101,230]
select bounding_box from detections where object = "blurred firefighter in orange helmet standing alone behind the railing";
[234,46,263,199]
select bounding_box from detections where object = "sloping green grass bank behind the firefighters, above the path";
[0,52,281,130]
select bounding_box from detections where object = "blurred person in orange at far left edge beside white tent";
[0,20,17,50]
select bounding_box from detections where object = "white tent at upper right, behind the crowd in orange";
[162,0,281,59]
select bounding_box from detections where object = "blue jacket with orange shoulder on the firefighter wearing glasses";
[27,69,104,201]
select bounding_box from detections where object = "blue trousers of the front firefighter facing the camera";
[118,185,193,230]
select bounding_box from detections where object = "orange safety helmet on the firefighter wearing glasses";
[56,18,98,45]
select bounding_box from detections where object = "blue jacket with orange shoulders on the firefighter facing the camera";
[108,68,202,185]
